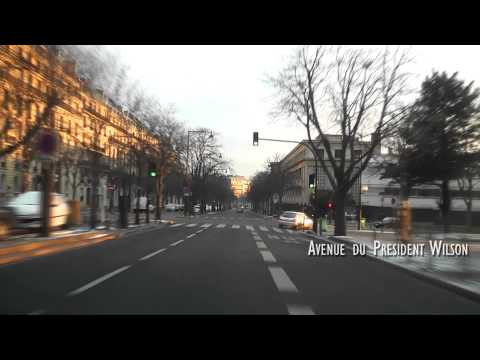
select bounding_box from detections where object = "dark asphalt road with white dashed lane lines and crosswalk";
[0,211,480,314]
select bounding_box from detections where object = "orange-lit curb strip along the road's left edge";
[0,232,118,265]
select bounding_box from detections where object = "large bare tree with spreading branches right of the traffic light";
[269,46,409,235]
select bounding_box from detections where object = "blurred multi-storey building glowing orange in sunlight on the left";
[0,45,158,218]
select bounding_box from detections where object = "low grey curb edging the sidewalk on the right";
[307,234,480,302]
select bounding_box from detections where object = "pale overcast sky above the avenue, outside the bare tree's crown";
[108,45,480,176]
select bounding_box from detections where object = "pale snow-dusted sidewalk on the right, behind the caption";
[309,229,480,300]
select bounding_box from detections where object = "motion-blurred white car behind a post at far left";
[7,191,70,228]
